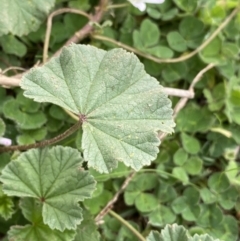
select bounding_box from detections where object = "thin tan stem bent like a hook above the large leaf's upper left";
[43,8,91,63]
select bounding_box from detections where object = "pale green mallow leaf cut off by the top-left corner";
[0,0,55,36]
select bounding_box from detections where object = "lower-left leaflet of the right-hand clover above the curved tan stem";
[167,31,187,52]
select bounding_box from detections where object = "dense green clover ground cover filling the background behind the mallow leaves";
[0,0,240,241]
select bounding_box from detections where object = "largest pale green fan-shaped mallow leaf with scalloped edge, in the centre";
[21,44,174,173]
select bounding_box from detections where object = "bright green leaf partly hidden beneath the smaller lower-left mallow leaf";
[8,198,76,241]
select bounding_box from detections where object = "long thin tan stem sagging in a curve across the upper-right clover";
[92,8,240,63]
